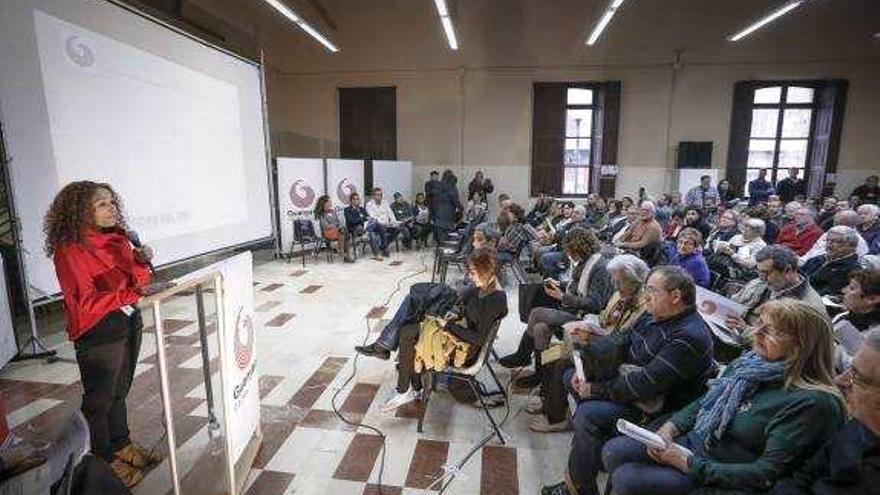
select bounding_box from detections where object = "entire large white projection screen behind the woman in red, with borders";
[0,0,273,299]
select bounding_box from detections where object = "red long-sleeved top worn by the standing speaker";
[54,229,150,341]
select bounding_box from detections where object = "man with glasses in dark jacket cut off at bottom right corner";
[770,329,880,495]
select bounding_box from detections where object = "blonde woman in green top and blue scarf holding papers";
[602,299,844,495]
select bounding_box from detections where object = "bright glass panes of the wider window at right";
[746,85,815,187]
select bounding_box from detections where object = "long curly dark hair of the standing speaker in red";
[43,180,126,257]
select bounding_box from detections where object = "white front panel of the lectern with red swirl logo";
[218,251,260,462]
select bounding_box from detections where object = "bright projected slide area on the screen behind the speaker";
[34,11,248,241]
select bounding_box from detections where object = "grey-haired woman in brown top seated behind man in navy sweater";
[526,254,650,433]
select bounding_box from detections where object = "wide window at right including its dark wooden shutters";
[727,79,848,197]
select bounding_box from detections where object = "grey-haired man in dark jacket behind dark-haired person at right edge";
[801,225,861,296]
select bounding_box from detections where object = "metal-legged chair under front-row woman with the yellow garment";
[417,320,508,445]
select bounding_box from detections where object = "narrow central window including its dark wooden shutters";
[531,81,620,196]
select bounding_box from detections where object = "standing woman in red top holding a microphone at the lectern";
[43,181,161,487]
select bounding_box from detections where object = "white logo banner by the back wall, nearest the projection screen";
[277,158,324,250]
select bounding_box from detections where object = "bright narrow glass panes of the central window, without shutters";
[562,88,593,195]
